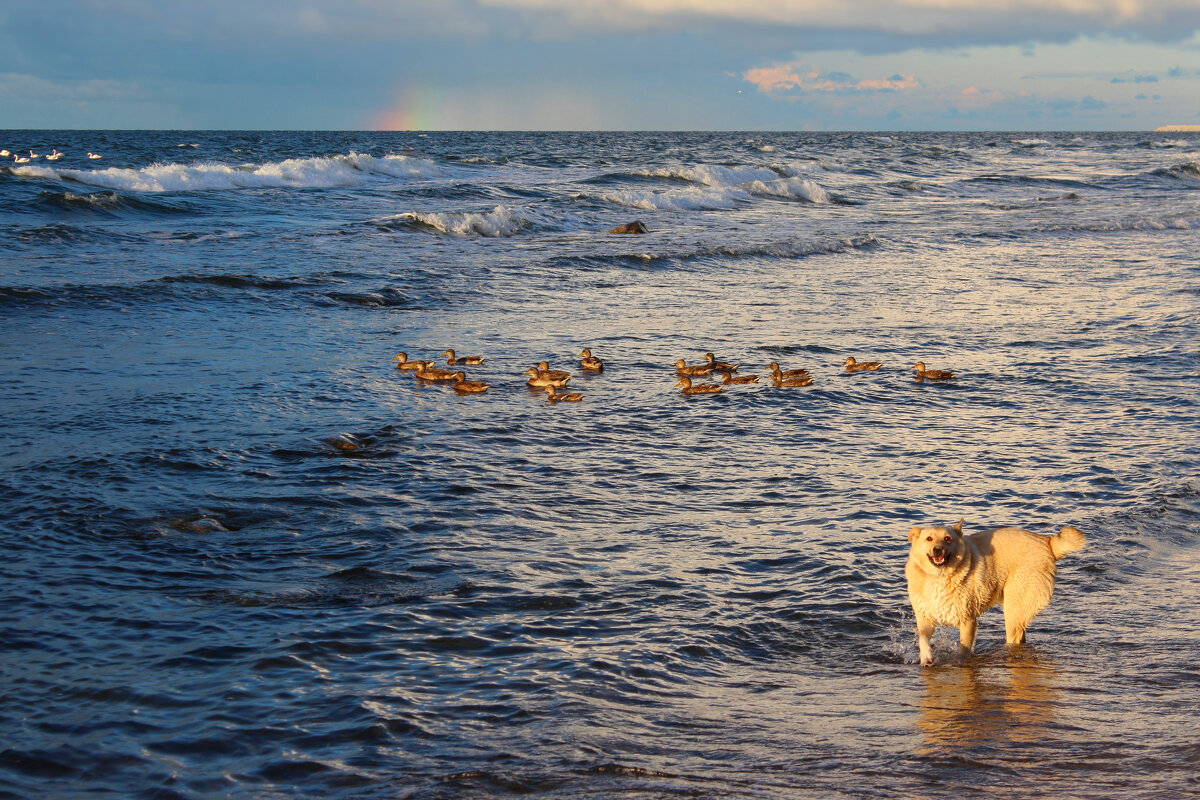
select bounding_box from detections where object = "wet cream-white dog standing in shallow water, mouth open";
[905,519,1084,667]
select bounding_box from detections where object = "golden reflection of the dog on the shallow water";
[917,644,1058,757]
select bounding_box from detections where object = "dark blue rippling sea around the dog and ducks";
[0,131,1200,799]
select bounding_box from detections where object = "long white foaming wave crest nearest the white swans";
[13,152,443,192]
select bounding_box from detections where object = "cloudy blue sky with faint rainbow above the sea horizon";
[0,0,1200,131]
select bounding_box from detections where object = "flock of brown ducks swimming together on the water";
[392,349,954,403]
